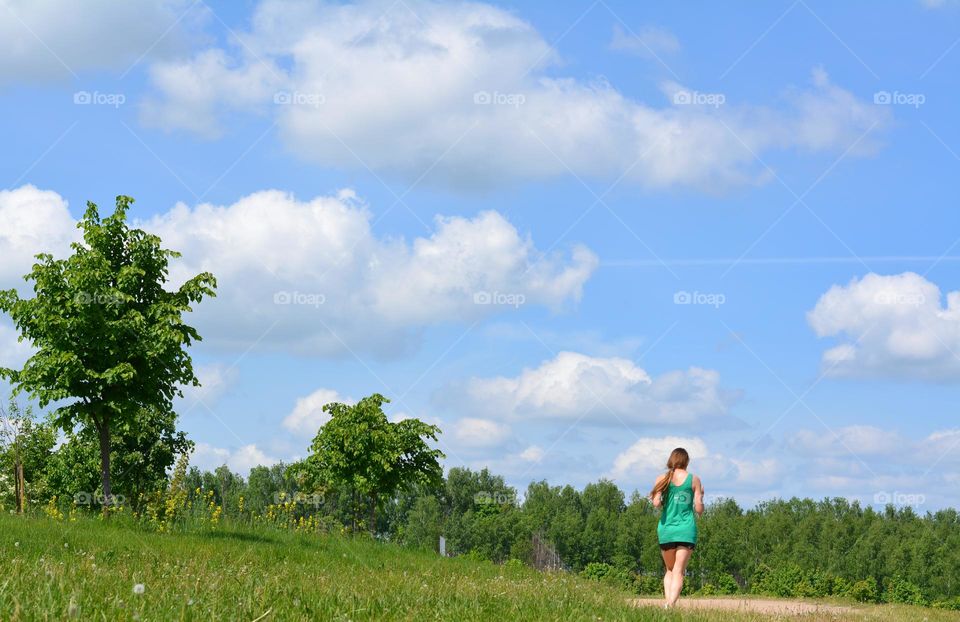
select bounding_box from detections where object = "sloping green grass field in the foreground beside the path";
[0,515,960,622]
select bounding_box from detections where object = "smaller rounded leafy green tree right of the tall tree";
[296,393,444,533]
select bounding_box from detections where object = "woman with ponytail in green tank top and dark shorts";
[650,447,703,608]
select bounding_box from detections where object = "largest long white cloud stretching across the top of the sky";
[142,0,889,189]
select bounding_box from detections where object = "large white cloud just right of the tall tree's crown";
[145,190,597,356]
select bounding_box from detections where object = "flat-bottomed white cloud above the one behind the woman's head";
[465,352,737,425]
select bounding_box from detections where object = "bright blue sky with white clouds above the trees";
[0,0,960,509]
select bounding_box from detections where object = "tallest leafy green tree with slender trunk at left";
[0,196,216,504]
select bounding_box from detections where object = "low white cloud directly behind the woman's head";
[609,436,784,491]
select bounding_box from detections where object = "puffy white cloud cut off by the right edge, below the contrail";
[807,272,960,381]
